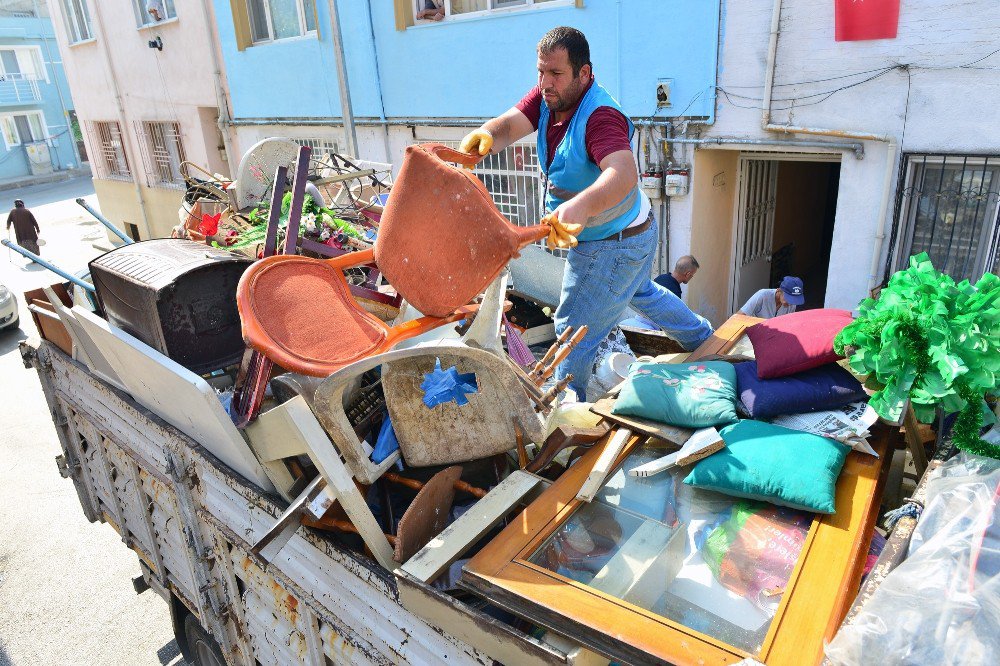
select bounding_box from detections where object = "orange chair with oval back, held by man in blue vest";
[236,144,549,377]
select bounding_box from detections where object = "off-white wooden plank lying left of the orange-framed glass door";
[400,471,542,583]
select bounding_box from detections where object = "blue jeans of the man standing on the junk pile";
[555,217,712,400]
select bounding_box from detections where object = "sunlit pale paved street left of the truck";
[0,178,184,666]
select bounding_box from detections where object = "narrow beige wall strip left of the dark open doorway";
[687,150,739,326]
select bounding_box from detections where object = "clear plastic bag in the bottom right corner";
[826,453,1000,665]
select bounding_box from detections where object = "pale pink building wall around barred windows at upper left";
[50,0,228,238]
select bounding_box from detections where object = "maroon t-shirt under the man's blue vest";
[516,79,632,168]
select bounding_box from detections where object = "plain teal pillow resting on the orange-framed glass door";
[684,421,851,513]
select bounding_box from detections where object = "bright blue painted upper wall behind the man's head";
[215,0,719,119]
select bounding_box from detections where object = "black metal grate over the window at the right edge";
[897,154,1000,280]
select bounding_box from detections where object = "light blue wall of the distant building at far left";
[0,17,80,179]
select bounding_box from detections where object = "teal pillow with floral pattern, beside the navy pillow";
[611,361,738,428]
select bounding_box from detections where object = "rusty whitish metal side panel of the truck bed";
[22,341,504,665]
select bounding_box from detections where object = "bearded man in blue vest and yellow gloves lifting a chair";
[461,27,712,400]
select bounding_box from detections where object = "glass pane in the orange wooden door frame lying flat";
[528,442,812,654]
